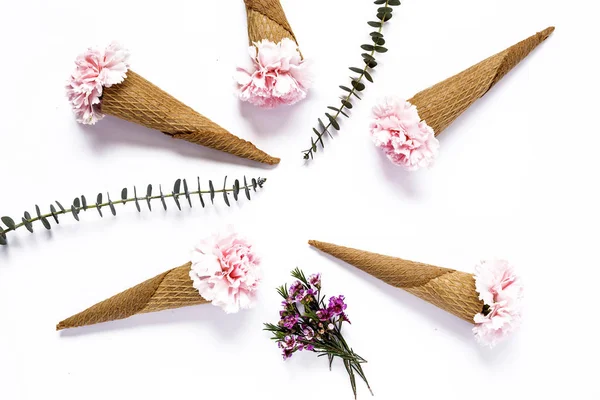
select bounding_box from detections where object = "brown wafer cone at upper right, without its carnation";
[408,27,554,136]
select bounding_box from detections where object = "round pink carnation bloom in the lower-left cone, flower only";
[190,233,261,314]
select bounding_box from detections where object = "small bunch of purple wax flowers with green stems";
[265,268,373,398]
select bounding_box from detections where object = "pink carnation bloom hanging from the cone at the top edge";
[234,38,311,108]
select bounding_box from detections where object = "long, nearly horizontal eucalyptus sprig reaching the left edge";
[0,176,266,245]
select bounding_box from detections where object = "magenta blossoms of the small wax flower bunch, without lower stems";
[270,274,349,359]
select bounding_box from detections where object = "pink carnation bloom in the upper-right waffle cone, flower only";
[371,97,440,171]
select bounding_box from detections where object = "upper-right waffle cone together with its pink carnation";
[371,27,554,170]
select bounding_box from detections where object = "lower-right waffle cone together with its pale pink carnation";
[309,240,522,346]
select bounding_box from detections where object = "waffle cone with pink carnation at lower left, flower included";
[56,233,261,330]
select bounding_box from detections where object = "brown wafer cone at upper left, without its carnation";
[102,70,279,165]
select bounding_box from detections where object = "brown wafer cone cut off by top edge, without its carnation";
[244,0,298,45]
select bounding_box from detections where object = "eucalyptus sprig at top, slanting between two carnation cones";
[303,0,400,160]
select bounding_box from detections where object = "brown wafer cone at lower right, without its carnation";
[309,240,483,323]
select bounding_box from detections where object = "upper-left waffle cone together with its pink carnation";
[66,43,279,165]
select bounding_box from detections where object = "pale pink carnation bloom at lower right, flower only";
[473,260,524,347]
